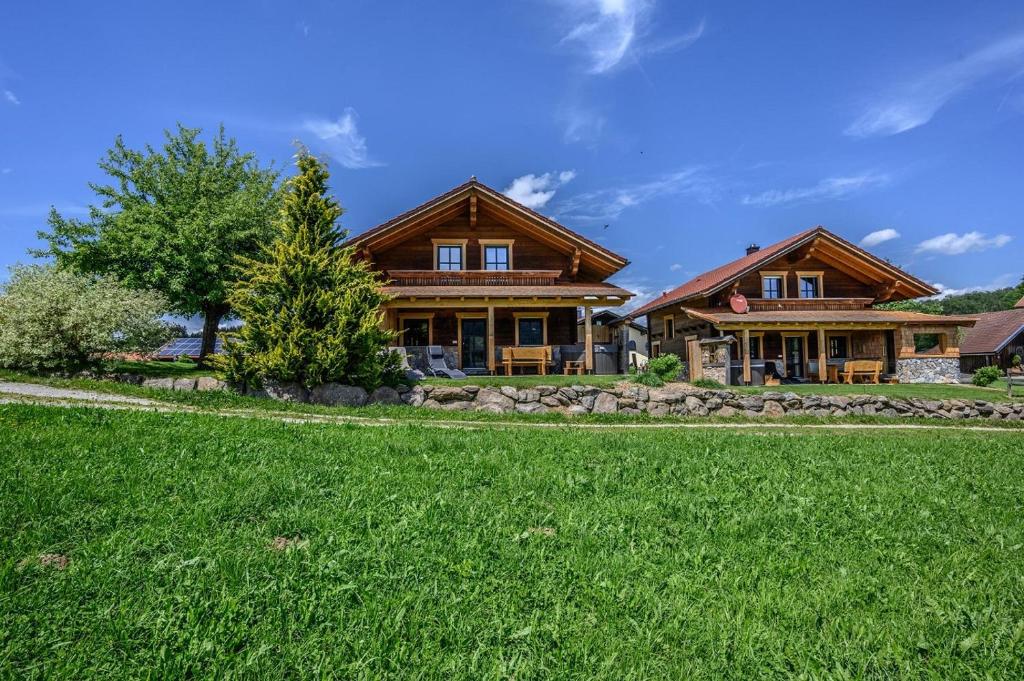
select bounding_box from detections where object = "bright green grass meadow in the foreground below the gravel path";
[0,406,1024,679]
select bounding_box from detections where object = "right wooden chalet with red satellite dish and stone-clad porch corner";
[632,226,975,384]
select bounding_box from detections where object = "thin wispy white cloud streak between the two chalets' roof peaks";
[555,167,718,221]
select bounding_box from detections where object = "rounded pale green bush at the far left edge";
[0,265,168,371]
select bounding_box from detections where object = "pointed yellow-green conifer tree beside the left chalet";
[219,150,399,389]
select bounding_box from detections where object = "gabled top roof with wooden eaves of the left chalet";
[346,177,629,276]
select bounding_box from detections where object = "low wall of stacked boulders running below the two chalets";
[401,383,1024,421]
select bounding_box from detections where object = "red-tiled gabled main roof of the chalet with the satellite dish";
[632,225,938,316]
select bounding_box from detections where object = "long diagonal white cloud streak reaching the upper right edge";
[844,33,1024,137]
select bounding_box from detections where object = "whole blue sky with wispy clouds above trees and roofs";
[0,0,1024,311]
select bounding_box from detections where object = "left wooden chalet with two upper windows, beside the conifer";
[346,177,633,374]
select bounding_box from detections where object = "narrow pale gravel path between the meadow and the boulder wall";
[0,381,1024,437]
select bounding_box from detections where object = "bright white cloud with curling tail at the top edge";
[560,0,705,74]
